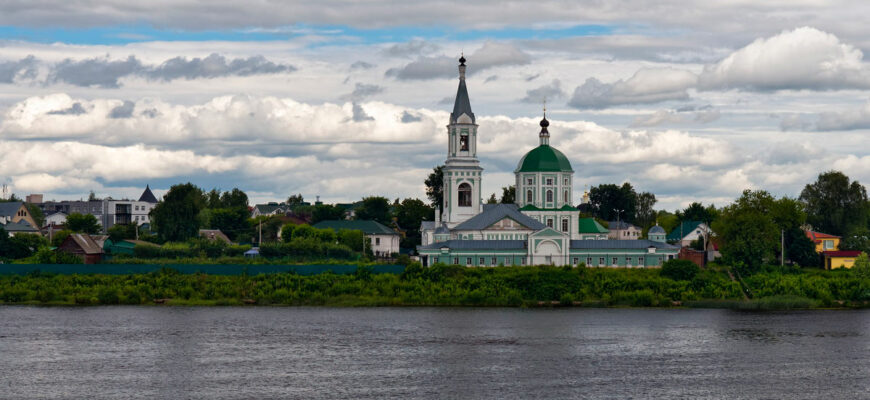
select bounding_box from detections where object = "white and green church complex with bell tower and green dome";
[417,57,680,268]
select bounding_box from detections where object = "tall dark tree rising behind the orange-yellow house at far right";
[799,171,868,236]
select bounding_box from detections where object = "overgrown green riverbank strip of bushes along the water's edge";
[0,264,870,310]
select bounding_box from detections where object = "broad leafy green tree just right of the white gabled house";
[713,190,780,274]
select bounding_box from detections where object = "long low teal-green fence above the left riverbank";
[0,264,405,275]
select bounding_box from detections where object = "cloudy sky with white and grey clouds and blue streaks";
[0,0,870,210]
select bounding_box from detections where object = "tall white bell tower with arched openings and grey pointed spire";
[441,56,483,228]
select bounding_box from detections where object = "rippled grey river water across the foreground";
[0,306,870,399]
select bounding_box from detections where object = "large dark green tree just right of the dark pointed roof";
[151,182,205,241]
